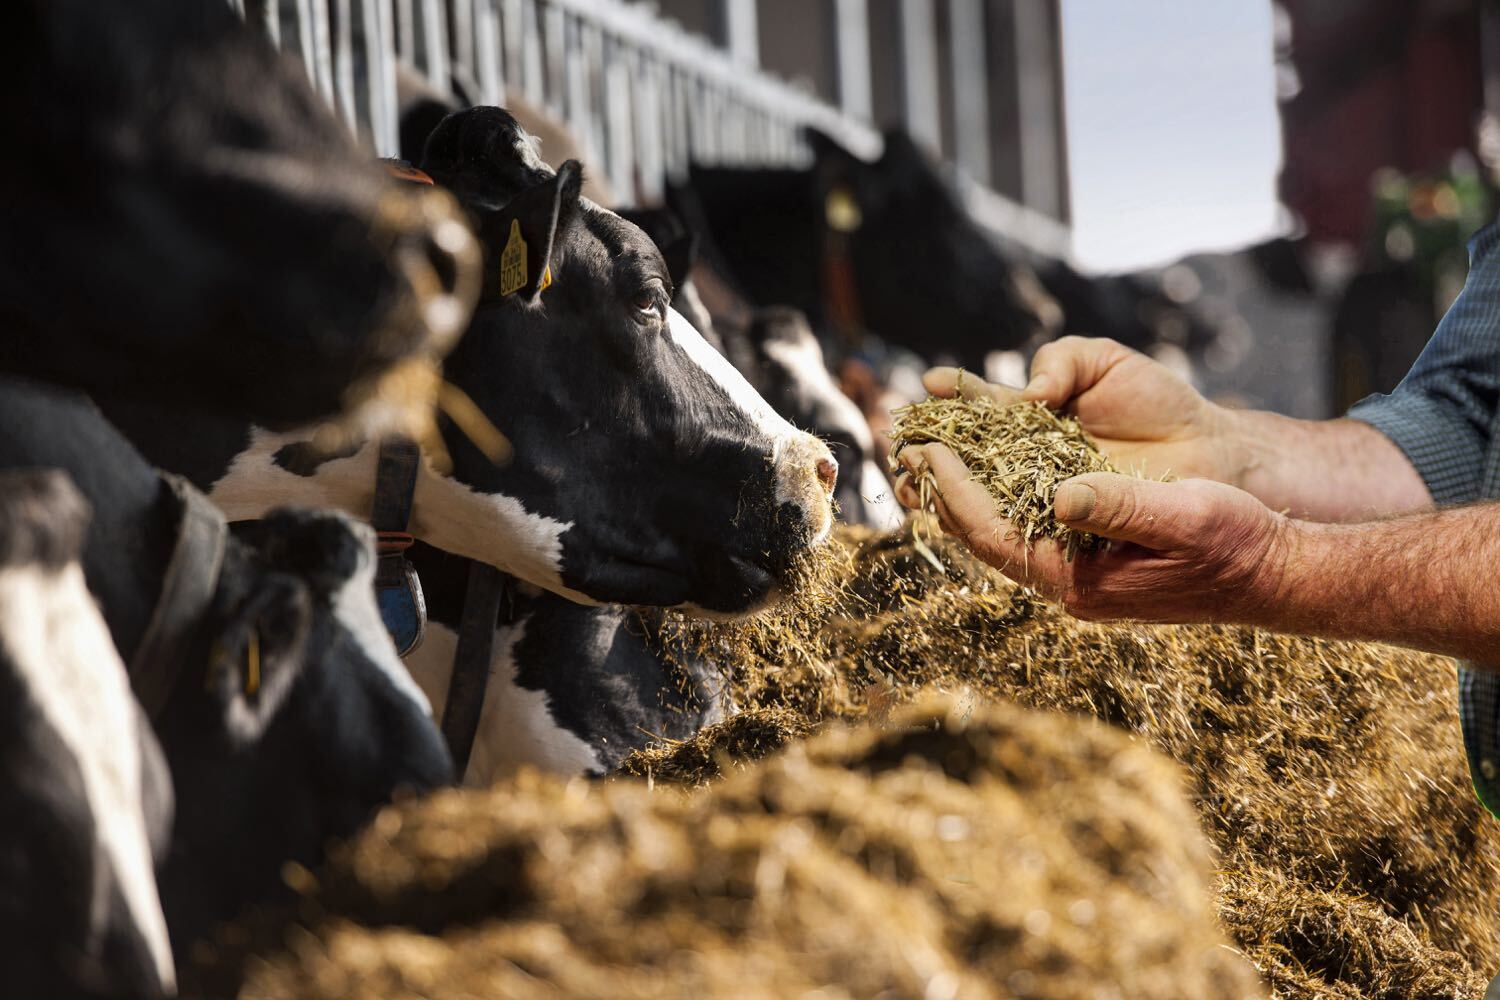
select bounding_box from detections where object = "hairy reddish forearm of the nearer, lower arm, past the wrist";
[1251,504,1500,666]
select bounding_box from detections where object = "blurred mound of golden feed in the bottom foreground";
[196,702,1263,1000]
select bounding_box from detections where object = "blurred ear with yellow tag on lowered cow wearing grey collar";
[204,573,312,747]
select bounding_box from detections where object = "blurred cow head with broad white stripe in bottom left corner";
[0,471,176,997]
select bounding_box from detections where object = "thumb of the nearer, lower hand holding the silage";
[1053,472,1208,549]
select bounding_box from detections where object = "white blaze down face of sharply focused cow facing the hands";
[668,309,834,544]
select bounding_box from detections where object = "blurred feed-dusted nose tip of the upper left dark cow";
[395,189,482,352]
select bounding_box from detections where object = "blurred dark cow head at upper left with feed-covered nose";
[0,0,477,426]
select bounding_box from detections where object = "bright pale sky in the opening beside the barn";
[1062,0,1281,270]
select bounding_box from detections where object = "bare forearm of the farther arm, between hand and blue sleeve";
[1220,411,1433,522]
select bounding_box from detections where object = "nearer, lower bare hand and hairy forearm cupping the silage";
[897,444,1500,664]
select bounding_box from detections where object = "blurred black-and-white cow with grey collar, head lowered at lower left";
[0,379,453,954]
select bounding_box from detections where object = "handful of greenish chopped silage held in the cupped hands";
[891,396,1118,559]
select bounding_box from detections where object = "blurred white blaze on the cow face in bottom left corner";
[0,562,177,994]
